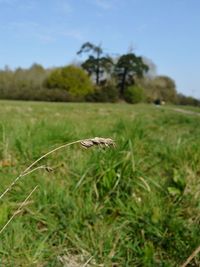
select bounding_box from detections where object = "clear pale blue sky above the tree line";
[0,0,200,98]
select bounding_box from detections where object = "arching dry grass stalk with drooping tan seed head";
[0,137,115,200]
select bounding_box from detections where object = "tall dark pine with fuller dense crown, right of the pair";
[115,53,149,97]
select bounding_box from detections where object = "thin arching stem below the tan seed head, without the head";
[0,139,84,200]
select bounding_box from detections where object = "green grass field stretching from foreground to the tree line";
[0,101,200,267]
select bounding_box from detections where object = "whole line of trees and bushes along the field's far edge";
[0,42,200,106]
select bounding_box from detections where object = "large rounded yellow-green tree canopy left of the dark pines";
[45,65,93,97]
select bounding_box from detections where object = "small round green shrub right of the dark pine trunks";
[124,85,145,104]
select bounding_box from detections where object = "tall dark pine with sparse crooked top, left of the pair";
[77,42,113,85]
